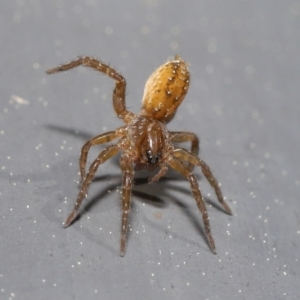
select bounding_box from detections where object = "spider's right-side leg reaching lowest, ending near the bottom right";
[168,156,216,254]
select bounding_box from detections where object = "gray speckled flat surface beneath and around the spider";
[0,0,300,300]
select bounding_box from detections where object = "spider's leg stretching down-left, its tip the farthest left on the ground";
[64,144,120,228]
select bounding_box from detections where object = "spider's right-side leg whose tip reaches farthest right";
[173,148,232,215]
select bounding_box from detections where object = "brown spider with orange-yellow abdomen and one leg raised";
[47,55,231,256]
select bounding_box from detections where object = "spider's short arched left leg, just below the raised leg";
[79,131,118,180]
